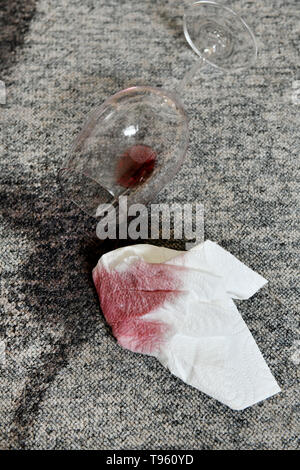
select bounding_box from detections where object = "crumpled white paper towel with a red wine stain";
[93,240,280,410]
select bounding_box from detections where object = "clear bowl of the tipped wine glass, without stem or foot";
[59,86,189,217]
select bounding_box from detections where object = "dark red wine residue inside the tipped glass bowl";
[117,145,157,188]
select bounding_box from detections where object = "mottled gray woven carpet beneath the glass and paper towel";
[0,0,300,449]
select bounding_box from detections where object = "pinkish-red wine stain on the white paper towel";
[93,259,181,354]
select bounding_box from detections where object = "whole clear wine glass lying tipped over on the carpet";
[59,1,257,217]
